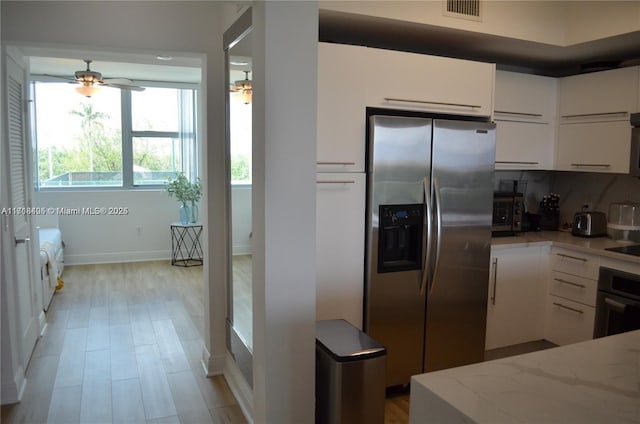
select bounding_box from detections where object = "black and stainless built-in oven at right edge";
[593,267,640,337]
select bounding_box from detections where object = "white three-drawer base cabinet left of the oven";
[544,247,600,345]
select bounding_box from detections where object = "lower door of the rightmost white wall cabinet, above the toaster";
[556,120,631,174]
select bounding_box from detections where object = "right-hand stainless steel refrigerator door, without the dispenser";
[424,120,495,372]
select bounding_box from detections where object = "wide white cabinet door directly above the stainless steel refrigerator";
[363,49,495,116]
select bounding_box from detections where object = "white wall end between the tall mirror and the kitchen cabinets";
[252,1,318,423]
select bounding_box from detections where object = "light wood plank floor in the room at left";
[2,261,246,424]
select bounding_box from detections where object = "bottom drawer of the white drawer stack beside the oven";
[545,295,596,345]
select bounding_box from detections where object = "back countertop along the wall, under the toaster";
[491,231,640,265]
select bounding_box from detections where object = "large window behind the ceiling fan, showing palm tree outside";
[33,81,197,190]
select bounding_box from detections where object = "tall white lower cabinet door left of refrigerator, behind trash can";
[316,173,365,329]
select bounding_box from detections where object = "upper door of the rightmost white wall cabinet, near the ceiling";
[559,67,640,119]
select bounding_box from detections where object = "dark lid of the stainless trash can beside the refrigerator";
[316,319,387,362]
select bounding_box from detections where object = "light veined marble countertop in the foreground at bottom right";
[410,330,640,424]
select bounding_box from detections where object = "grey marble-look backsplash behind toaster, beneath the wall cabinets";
[495,171,640,232]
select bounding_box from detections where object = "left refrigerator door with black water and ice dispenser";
[364,116,432,386]
